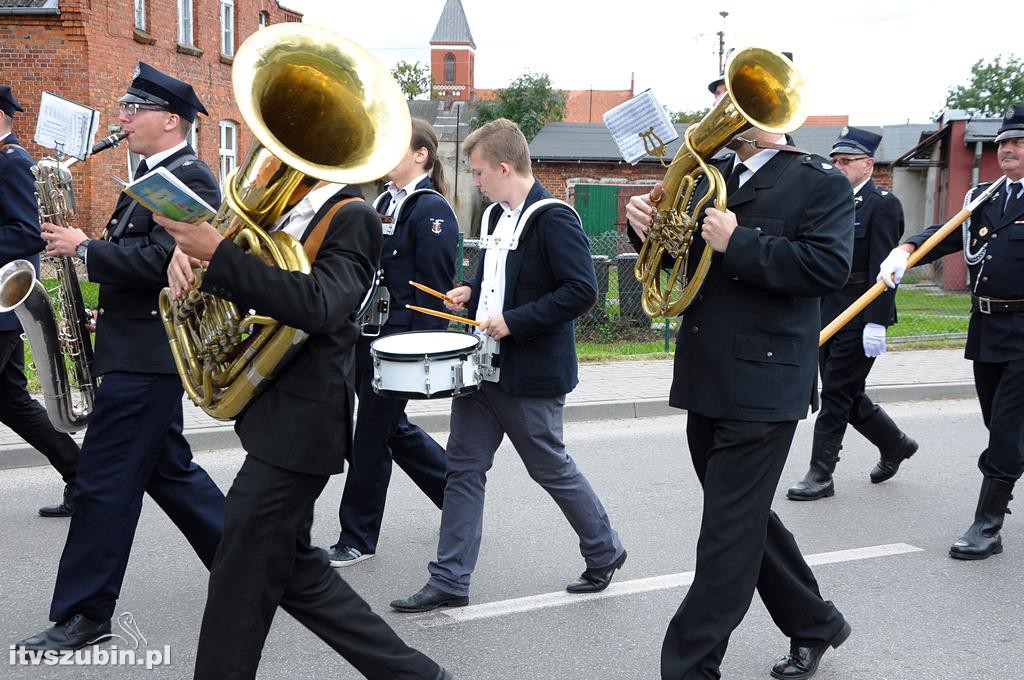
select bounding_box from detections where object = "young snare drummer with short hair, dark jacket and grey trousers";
[391,119,626,611]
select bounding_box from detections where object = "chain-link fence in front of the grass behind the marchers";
[458,231,971,357]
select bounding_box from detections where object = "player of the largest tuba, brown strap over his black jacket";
[157,182,451,680]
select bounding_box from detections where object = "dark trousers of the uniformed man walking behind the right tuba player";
[814,326,879,434]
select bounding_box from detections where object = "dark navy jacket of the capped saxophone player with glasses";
[86,145,220,375]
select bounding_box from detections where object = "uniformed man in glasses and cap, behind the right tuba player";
[785,127,918,501]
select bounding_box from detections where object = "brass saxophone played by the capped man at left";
[0,132,127,432]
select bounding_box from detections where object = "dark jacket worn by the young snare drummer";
[469,181,597,396]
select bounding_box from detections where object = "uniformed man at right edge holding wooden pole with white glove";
[878,104,1024,559]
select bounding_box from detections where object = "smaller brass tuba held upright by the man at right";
[635,47,807,316]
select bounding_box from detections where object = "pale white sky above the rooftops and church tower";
[282,0,1024,125]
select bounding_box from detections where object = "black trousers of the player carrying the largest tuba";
[196,456,440,680]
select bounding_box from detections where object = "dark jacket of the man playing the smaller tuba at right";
[630,152,854,422]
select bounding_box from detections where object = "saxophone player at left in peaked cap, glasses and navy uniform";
[16,62,224,650]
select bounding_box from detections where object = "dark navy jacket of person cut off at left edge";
[0,133,46,331]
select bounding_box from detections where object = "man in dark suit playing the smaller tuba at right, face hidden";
[627,115,854,680]
